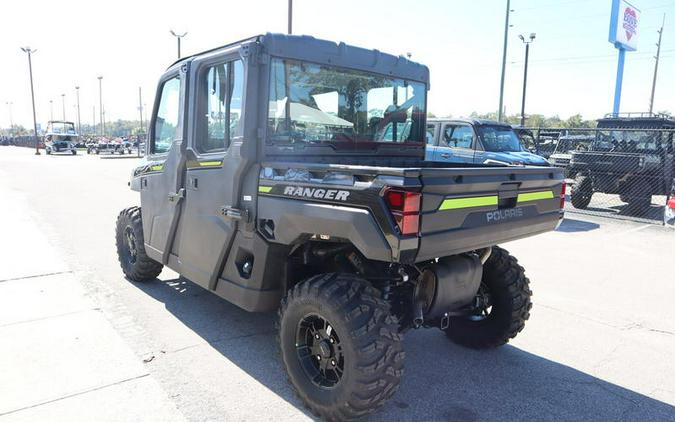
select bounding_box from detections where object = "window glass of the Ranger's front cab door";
[150,76,180,154]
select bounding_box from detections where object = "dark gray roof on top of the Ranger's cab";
[169,33,429,86]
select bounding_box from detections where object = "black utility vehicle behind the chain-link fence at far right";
[569,113,675,213]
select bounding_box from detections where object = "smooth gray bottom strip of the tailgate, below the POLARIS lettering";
[415,212,561,262]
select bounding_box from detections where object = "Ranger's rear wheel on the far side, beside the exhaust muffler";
[445,246,532,349]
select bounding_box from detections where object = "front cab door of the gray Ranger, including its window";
[140,64,188,264]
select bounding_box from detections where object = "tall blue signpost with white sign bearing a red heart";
[609,0,640,115]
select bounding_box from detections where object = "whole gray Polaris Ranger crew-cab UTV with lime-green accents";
[116,34,563,420]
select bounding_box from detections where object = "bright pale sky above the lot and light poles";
[0,0,675,127]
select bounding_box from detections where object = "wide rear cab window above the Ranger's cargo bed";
[267,59,426,144]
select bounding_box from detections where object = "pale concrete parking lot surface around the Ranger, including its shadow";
[0,147,675,421]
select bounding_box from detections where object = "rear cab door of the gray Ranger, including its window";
[178,52,247,290]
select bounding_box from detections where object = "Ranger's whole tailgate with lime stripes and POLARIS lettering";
[416,167,563,261]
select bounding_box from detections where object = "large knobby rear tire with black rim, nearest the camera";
[278,273,405,420]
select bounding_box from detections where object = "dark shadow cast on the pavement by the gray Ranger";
[134,276,675,421]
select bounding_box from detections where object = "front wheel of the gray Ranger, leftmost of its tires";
[115,207,162,281]
